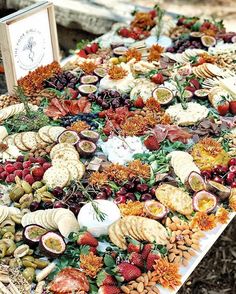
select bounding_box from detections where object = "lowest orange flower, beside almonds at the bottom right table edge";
[152,258,181,289]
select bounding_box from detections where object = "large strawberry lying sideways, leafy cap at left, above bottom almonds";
[115,261,142,282]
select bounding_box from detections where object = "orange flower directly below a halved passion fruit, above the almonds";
[191,211,216,231]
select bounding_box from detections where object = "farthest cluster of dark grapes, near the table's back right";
[167,39,205,53]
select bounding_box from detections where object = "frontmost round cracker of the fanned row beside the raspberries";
[43,166,70,188]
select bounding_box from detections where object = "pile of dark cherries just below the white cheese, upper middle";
[88,90,131,109]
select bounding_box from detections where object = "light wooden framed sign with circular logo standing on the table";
[0,1,59,93]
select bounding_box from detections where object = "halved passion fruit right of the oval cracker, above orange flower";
[193,190,217,213]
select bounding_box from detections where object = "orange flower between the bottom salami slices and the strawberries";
[80,252,103,278]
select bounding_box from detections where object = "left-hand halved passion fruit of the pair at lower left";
[23,225,47,247]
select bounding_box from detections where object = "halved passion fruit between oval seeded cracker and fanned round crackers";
[144,200,168,219]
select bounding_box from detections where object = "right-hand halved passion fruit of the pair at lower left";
[39,232,66,258]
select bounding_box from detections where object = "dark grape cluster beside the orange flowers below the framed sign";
[45,71,79,91]
